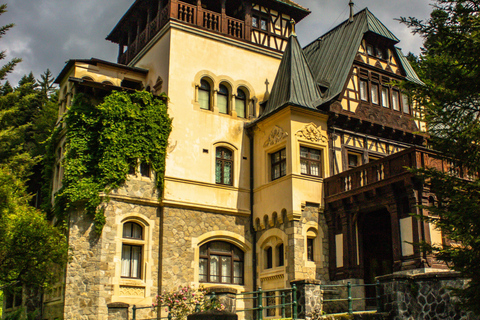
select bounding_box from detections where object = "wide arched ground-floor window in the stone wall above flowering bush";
[199,241,244,284]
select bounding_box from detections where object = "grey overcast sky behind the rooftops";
[0,0,432,85]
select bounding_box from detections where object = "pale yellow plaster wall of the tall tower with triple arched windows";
[136,25,281,214]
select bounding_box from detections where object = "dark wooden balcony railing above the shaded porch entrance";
[324,147,452,203]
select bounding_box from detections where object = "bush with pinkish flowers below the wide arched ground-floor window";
[153,286,225,320]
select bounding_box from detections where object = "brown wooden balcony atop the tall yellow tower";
[118,0,251,65]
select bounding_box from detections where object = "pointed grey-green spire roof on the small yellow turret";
[261,35,320,118]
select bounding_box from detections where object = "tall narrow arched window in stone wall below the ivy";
[122,222,143,279]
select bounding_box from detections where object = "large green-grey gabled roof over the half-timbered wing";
[303,8,403,103]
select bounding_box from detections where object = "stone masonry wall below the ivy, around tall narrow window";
[63,177,160,320]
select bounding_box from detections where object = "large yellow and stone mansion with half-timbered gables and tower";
[35,0,460,319]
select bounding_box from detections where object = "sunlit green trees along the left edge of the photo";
[0,5,68,309]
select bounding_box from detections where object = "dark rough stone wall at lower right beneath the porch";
[378,272,478,320]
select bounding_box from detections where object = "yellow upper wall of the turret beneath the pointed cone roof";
[254,108,330,223]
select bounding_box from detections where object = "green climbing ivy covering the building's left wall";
[45,91,172,233]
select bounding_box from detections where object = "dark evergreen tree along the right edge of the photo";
[401,0,480,314]
